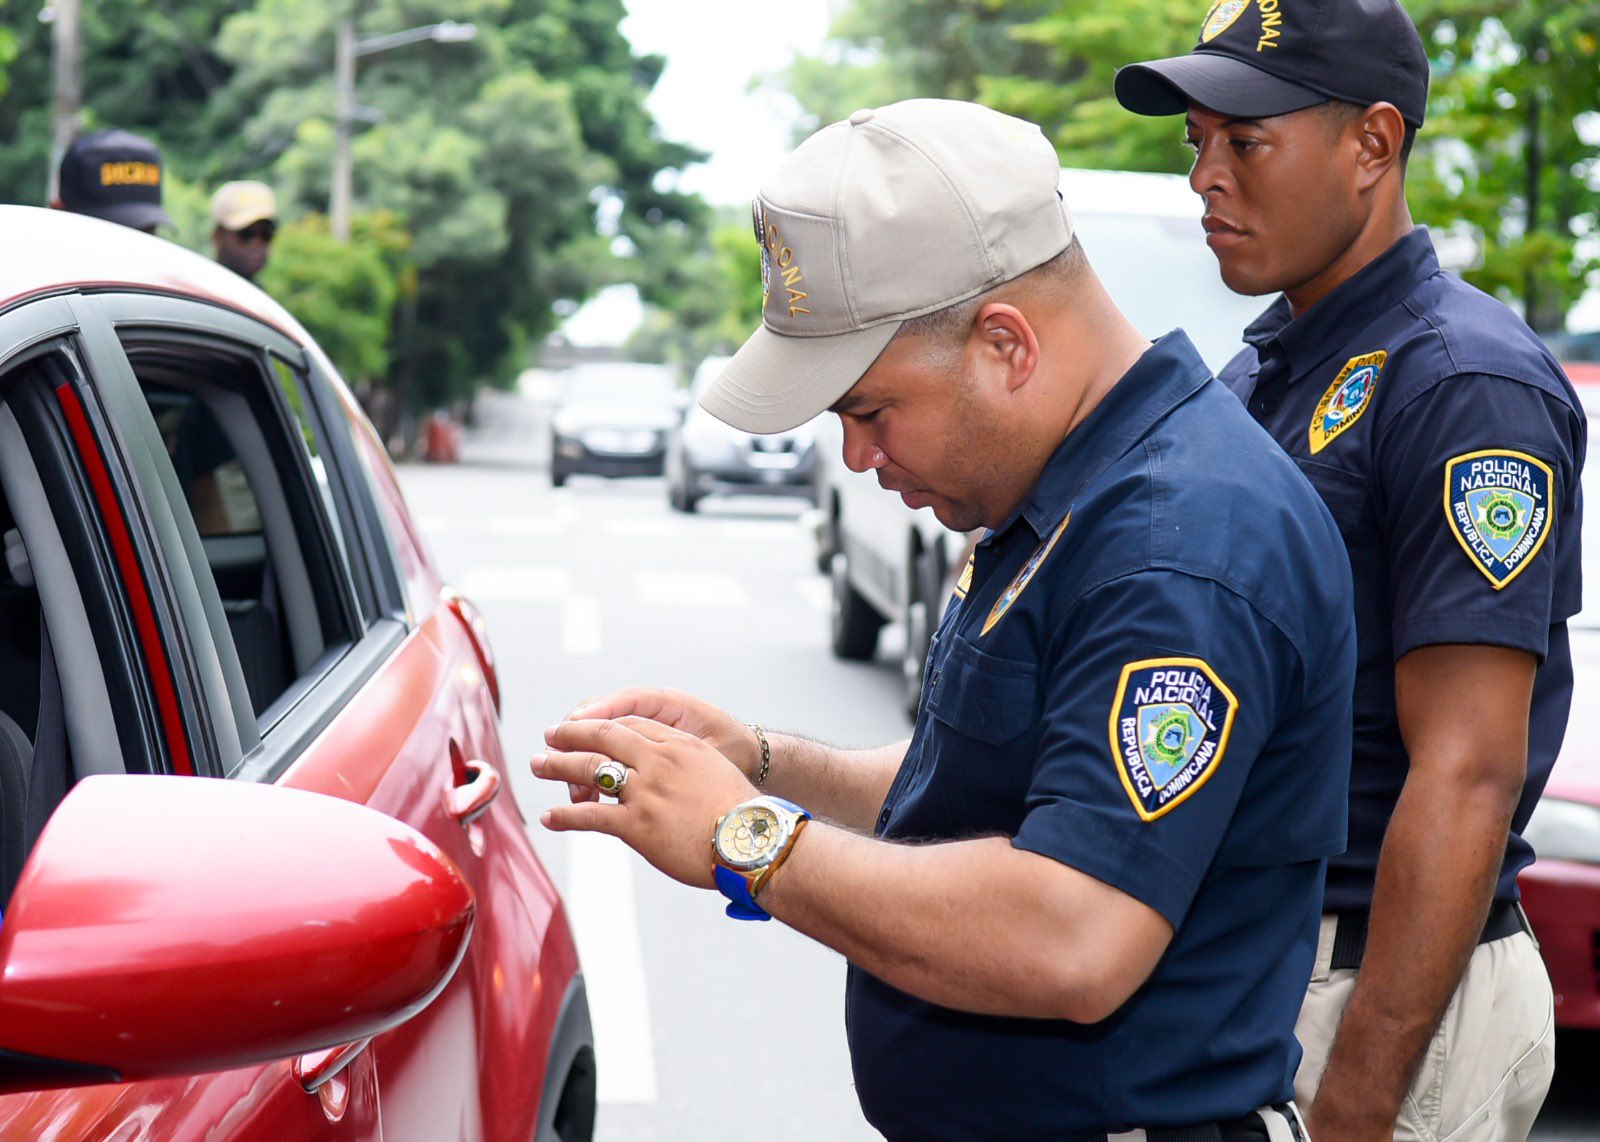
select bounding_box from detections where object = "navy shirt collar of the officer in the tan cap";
[986,329,1211,542]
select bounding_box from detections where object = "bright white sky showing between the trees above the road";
[563,0,829,345]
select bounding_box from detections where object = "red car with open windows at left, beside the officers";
[0,206,595,1142]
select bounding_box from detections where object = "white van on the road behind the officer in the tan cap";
[816,170,1270,717]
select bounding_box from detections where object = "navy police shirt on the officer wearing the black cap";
[1222,227,1587,912]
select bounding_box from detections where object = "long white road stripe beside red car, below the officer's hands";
[566,833,658,1102]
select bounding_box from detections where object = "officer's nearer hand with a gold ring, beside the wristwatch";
[531,716,755,888]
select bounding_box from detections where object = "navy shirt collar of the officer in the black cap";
[1245,226,1438,384]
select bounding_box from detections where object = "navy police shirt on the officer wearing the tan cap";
[846,333,1355,1140]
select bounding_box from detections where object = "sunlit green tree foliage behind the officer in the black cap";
[771,0,1600,328]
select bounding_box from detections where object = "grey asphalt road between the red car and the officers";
[402,405,1600,1142]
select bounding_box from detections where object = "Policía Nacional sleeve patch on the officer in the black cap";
[1445,448,1555,590]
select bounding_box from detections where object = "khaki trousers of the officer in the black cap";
[1294,916,1555,1142]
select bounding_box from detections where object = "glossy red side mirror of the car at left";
[0,776,475,1092]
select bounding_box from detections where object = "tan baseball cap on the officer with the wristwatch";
[701,99,1072,432]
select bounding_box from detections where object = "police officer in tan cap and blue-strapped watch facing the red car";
[533,101,1354,1142]
